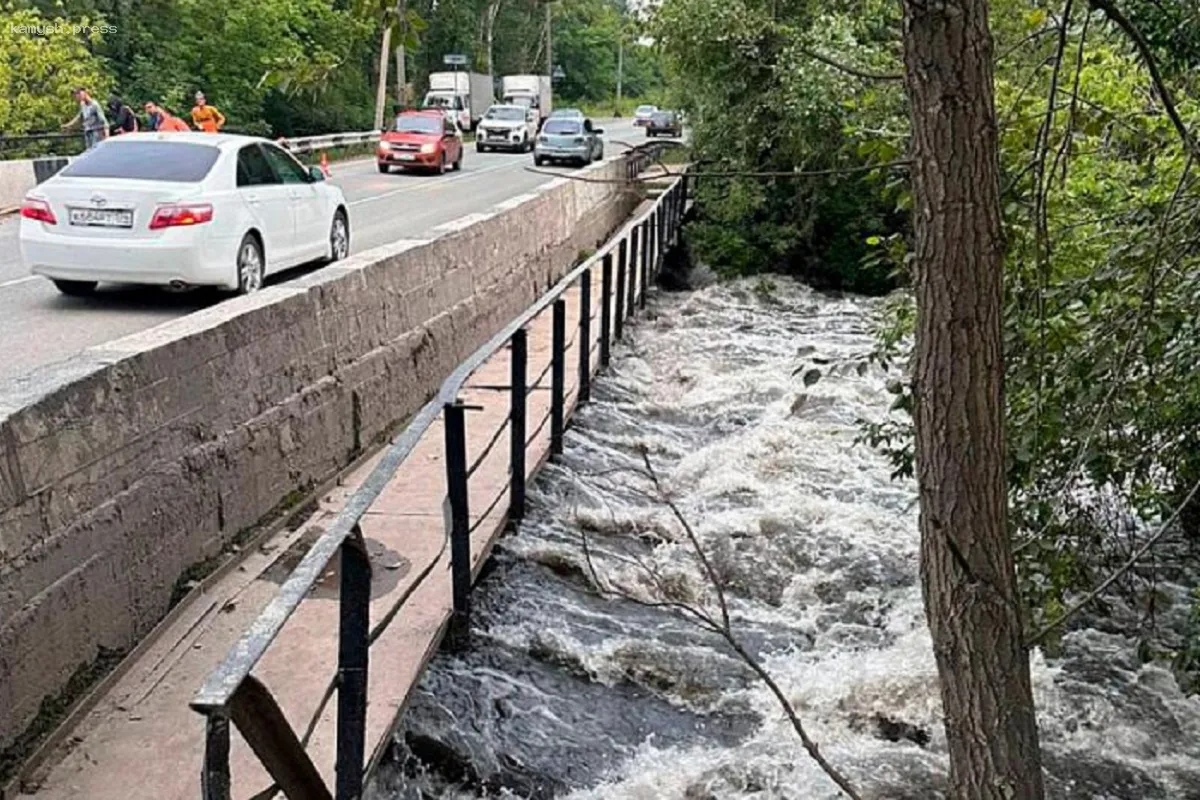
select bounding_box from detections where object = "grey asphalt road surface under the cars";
[0,121,644,384]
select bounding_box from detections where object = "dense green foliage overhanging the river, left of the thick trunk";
[653,0,905,294]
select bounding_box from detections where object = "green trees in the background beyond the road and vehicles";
[0,0,661,137]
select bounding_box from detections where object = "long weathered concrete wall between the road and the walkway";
[0,155,632,748]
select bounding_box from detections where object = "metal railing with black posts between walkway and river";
[191,149,689,800]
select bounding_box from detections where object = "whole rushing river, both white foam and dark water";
[377,281,1200,800]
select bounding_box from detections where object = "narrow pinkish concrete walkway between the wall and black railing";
[11,227,636,800]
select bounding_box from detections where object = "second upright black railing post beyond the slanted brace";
[443,403,470,649]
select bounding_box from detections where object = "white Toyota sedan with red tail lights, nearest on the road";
[19,132,350,295]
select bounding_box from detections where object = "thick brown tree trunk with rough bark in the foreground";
[904,0,1043,800]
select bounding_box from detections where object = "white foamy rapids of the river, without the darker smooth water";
[499,279,1200,800]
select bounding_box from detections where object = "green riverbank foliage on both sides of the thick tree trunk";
[658,0,1200,663]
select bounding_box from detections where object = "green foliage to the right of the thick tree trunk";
[863,0,1200,652]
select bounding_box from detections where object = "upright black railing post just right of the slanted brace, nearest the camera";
[336,525,371,800]
